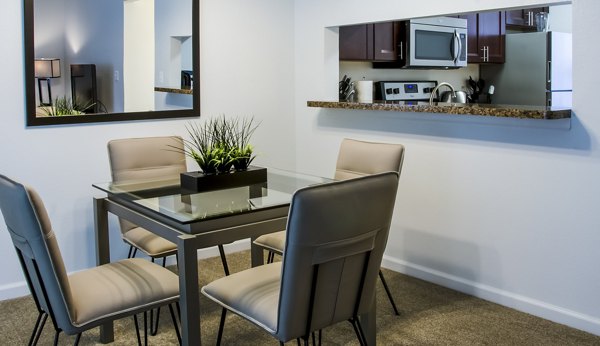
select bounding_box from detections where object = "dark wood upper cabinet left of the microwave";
[339,22,399,61]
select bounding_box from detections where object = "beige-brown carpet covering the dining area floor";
[0,251,600,346]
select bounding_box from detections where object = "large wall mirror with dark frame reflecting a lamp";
[24,0,200,126]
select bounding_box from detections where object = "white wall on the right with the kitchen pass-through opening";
[295,0,600,335]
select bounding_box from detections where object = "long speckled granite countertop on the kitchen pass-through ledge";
[307,101,571,119]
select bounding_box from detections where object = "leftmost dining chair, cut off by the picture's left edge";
[0,175,179,345]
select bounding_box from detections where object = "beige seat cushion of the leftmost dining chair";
[69,258,179,326]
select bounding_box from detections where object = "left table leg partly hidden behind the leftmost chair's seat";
[94,197,115,344]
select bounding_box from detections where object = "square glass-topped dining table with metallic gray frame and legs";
[93,168,375,345]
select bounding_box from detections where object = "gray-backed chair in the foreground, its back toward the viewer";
[202,172,398,344]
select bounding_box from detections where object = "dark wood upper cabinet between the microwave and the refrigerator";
[460,11,506,63]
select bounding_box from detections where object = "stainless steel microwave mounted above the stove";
[398,17,467,68]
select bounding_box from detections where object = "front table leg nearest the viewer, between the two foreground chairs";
[177,235,201,345]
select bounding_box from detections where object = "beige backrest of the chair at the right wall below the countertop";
[334,138,404,180]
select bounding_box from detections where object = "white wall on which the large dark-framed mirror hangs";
[0,0,295,299]
